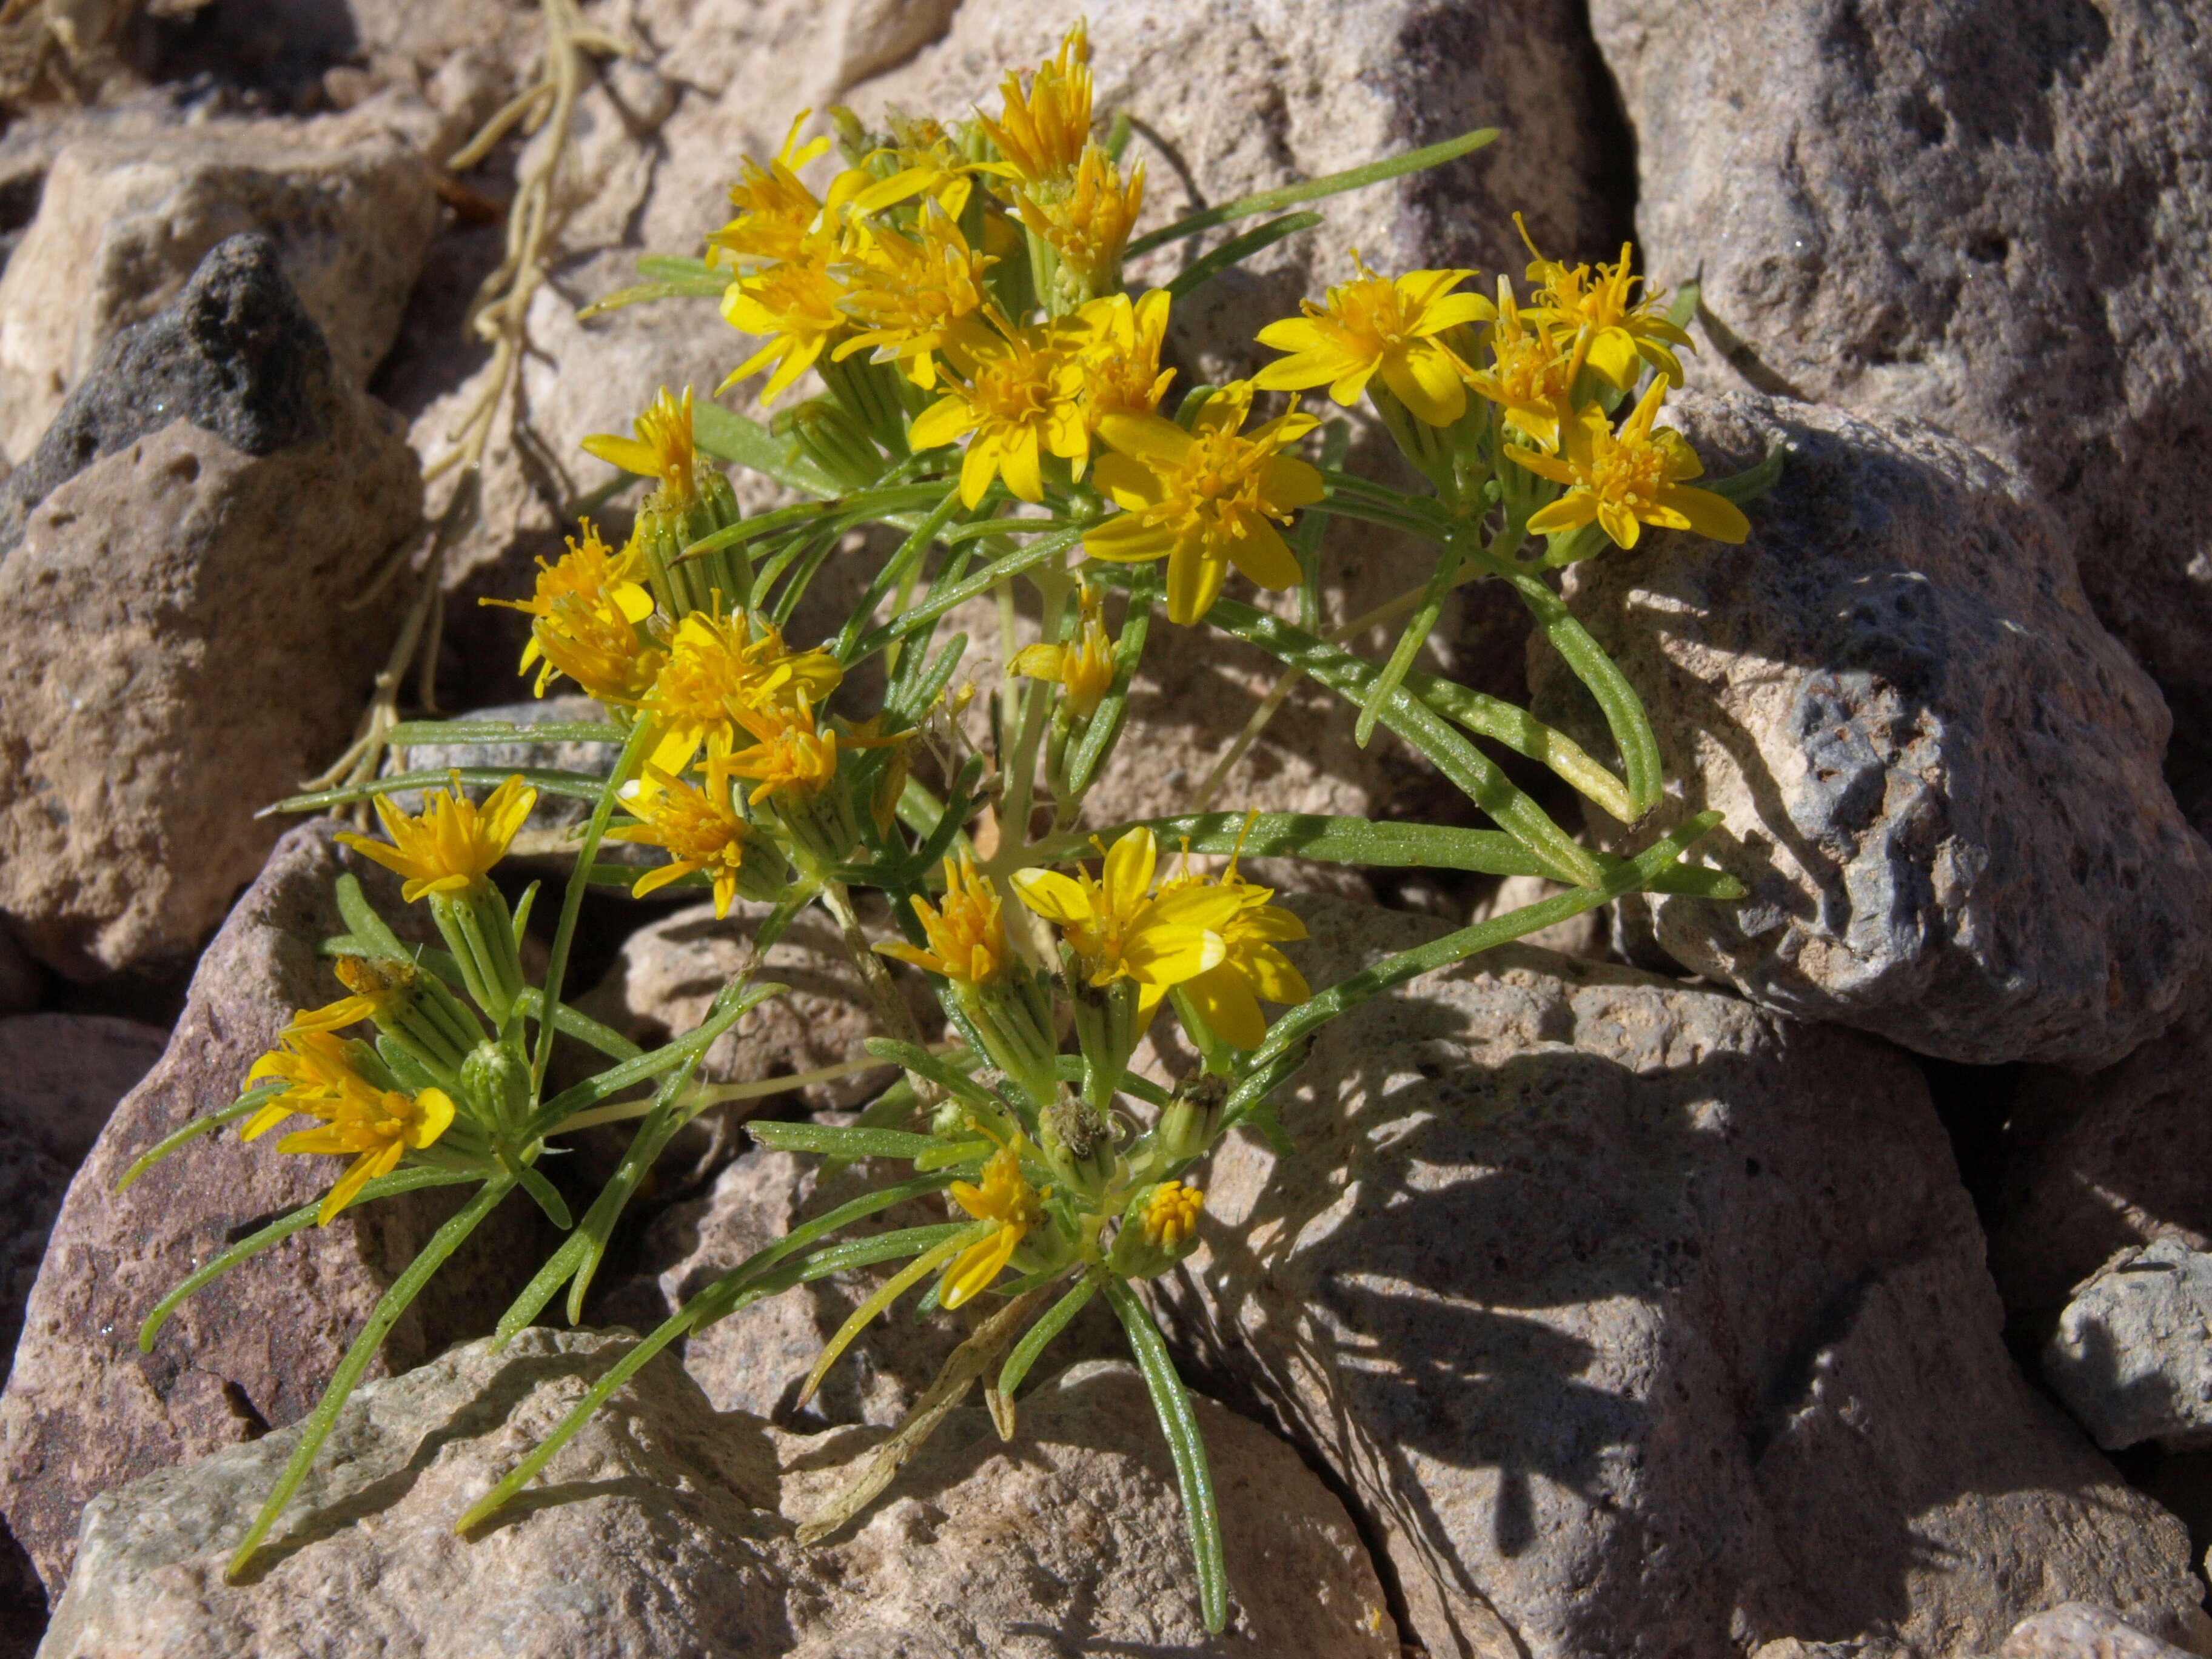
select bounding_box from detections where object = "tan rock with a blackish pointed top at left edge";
[0,241,420,980]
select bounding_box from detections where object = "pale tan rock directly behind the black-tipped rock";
[0,110,438,458]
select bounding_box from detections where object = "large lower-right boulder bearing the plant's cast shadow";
[1159,898,2205,1659]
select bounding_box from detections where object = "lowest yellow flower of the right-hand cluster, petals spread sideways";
[1506,378,1752,546]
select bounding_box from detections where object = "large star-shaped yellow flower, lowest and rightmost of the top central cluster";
[1084,380,1321,622]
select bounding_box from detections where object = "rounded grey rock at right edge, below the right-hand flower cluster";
[1530,394,2212,1066]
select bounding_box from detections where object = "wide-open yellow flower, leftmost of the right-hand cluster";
[1252,250,1493,427]
